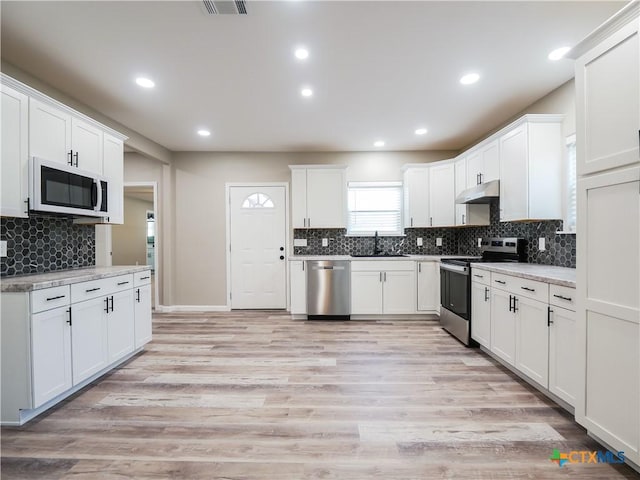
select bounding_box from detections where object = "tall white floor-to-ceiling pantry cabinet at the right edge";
[572,1,640,466]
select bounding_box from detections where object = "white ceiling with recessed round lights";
[1,0,625,151]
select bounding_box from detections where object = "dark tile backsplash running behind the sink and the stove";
[293,202,576,268]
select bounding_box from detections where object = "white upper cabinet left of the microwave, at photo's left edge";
[0,85,29,217]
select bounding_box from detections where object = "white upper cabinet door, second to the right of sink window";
[429,162,456,227]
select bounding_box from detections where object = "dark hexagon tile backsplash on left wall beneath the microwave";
[0,214,95,277]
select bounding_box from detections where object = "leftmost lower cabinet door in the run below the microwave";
[31,305,73,408]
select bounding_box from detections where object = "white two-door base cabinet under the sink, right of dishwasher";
[351,260,417,315]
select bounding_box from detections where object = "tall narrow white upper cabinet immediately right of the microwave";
[102,133,124,224]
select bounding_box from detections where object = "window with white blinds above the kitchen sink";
[347,182,403,235]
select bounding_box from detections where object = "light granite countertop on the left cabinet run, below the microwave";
[0,265,151,292]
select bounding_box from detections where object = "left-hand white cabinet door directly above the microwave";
[29,98,71,164]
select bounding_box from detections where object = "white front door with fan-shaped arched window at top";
[229,186,287,309]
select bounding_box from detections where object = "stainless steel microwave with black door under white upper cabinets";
[29,157,108,217]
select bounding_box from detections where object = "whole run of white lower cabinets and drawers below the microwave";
[0,271,151,425]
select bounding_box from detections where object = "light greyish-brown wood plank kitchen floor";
[1,312,640,480]
